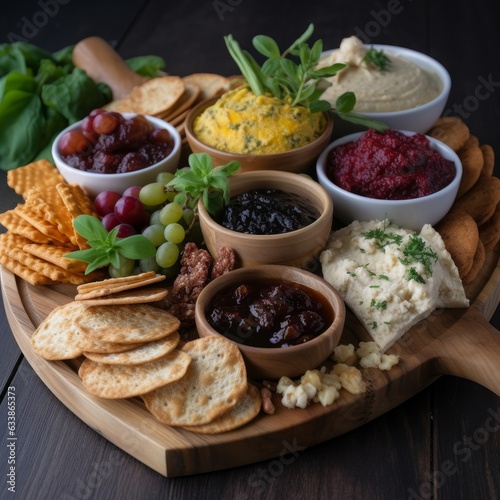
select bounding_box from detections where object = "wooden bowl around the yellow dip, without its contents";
[185,97,333,172]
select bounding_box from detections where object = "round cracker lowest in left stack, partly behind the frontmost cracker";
[78,349,191,399]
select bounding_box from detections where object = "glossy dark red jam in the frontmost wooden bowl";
[206,282,332,347]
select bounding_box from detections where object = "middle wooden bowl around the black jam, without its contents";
[198,170,333,270]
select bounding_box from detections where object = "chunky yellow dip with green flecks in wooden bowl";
[193,86,326,154]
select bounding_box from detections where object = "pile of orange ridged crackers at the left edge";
[0,160,102,285]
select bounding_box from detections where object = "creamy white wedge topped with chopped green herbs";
[320,220,469,352]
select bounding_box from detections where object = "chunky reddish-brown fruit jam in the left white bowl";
[58,109,174,174]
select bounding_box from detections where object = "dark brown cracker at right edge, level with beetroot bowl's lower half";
[452,175,500,225]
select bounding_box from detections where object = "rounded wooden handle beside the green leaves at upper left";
[73,36,146,99]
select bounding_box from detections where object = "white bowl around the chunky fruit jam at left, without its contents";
[52,113,182,197]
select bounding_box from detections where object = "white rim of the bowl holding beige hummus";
[322,44,451,118]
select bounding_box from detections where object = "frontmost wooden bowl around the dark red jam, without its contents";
[195,266,345,380]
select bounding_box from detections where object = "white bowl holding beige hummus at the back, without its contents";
[323,44,451,133]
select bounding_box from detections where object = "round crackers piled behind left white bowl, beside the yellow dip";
[105,73,230,142]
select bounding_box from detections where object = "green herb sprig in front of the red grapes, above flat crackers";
[66,215,156,274]
